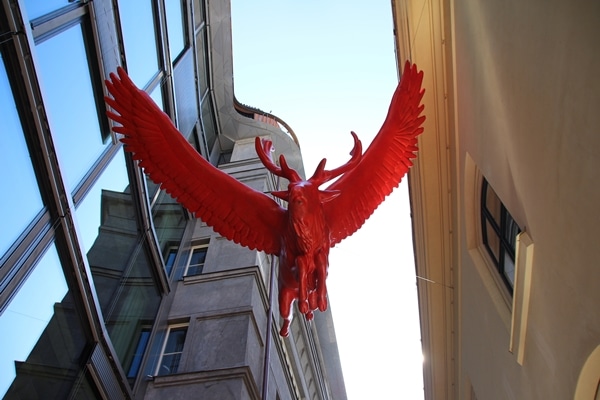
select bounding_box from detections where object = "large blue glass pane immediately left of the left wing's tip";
[36,25,104,191]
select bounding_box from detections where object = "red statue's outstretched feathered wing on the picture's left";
[105,68,286,254]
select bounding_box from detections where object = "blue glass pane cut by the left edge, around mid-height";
[0,55,42,257]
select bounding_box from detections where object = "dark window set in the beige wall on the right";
[481,179,521,293]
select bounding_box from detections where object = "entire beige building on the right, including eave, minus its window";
[395,0,600,400]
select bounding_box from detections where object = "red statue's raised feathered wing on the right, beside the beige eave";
[323,61,425,246]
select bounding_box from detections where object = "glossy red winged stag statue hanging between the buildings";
[105,61,425,336]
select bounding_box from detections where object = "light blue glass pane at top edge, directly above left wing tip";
[118,0,159,87]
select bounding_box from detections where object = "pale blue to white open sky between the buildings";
[232,0,423,400]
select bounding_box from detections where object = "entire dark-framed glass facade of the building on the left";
[0,0,215,399]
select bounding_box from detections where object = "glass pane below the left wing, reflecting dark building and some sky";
[76,148,161,380]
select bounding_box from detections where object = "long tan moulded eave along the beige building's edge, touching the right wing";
[392,0,460,399]
